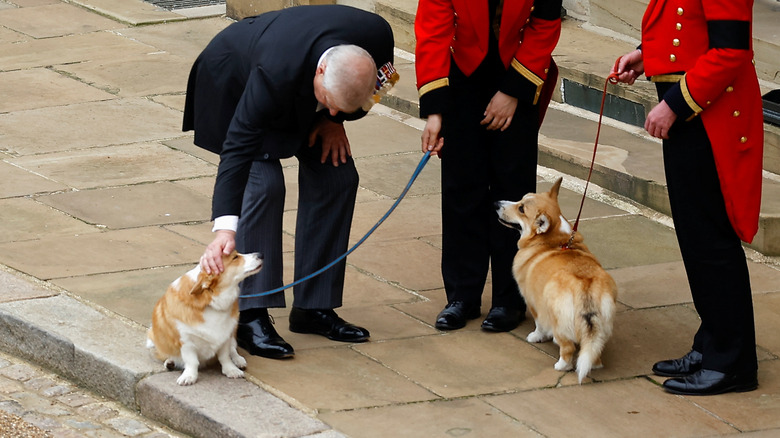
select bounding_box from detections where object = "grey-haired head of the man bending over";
[322,44,376,112]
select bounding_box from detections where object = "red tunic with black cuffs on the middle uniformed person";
[415,0,561,117]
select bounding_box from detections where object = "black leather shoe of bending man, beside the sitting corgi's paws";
[236,309,295,359]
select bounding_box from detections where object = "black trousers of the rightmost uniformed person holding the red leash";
[659,84,758,373]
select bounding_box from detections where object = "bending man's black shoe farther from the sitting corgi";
[290,307,371,342]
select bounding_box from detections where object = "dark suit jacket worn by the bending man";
[183,5,394,219]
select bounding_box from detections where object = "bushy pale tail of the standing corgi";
[577,294,614,384]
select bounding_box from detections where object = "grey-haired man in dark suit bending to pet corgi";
[183,5,394,359]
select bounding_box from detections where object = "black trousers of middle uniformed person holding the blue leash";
[441,63,539,309]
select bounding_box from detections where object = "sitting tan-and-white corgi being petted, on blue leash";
[146,251,263,385]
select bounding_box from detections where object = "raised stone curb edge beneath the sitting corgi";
[0,271,341,438]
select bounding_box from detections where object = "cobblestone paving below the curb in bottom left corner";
[0,353,185,438]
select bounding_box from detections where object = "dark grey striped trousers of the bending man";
[236,146,358,310]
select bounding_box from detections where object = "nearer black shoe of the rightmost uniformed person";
[664,369,758,395]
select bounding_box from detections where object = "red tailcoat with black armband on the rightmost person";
[642,0,764,242]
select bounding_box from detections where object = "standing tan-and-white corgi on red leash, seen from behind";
[496,178,617,383]
